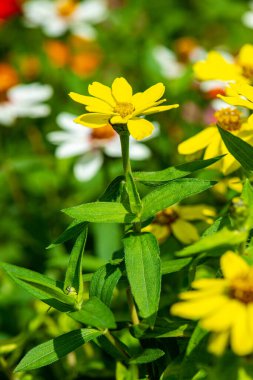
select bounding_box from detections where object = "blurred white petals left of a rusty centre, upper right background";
[152,45,185,79]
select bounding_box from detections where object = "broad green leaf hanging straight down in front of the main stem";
[123,233,161,318]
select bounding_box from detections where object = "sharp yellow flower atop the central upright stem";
[69,77,179,140]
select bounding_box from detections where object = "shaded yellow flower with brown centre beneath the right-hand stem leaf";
[143,205,215,244]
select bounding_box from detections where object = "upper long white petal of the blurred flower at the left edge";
[7,83,53,105]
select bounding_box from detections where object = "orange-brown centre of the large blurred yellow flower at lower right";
[230,275,253,304]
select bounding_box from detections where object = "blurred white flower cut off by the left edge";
[0,83,53,126]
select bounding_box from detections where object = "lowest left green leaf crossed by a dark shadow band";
[14,329,102,372]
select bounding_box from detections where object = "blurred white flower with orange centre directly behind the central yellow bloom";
[47,112,159,181]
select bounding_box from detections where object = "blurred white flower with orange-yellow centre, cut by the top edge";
[23,0,107,39]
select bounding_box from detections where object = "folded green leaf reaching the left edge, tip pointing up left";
[0,263,75,311]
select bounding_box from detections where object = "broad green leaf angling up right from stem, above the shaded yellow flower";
[141,178,215,221]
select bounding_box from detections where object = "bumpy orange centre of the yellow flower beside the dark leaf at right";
[214,108,242,131]
